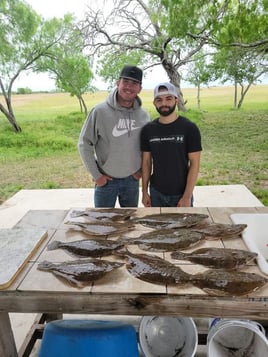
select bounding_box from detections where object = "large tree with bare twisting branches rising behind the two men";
[82,0,268,109]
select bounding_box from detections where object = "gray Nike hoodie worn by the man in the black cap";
[78,88,150,180]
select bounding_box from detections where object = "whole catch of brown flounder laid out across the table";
[35,209,268,296]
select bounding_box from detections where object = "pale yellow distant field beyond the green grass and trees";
[5,85,268,114]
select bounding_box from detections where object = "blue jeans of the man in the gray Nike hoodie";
[94,175,139,208]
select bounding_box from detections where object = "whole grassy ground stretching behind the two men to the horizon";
[0,86,268,206]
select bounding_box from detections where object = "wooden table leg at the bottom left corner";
[0,312,18,357]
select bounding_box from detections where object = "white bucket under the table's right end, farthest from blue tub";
[207,319,268,357]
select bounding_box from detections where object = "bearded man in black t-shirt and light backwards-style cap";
[141,83,202,207]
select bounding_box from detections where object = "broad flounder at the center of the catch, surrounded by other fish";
[120,228,205,252]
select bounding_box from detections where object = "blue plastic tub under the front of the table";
[39,320,139,357]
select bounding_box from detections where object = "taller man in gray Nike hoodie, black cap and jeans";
[78,65,150,207]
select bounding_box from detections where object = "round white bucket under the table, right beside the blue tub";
[139,316,198,357]
